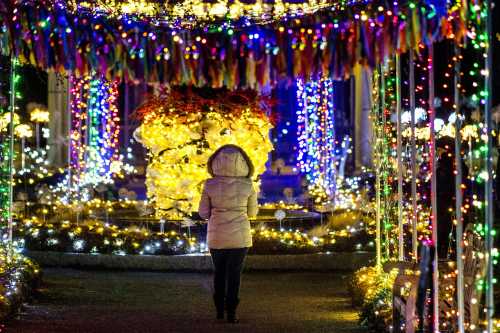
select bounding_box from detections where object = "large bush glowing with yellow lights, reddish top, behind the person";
[135,89,272,218]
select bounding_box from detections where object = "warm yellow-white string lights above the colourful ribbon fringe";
[69,0,410,27]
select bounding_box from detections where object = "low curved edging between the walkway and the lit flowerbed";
[25,251,374,272]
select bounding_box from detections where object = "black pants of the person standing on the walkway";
[210,247,248,313]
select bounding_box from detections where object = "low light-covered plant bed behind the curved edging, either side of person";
[15,219,372,255]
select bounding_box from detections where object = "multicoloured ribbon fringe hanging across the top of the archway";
[0,0,465,90]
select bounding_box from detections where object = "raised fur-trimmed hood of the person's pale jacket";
[208,145,254,178]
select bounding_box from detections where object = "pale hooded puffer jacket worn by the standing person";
[198,145,258,249]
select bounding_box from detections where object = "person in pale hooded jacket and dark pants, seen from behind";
[198,145,258,323]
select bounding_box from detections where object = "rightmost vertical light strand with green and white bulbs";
[457,1,499,332]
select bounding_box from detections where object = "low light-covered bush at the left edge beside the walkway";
[0,247,41,321]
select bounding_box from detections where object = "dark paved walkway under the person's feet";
[6,269,362,333]
